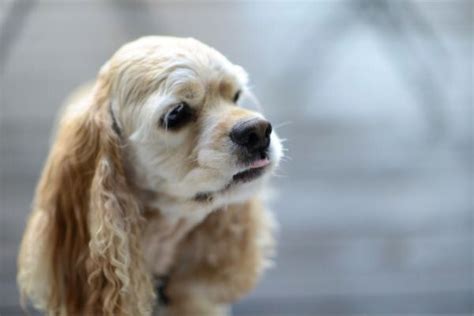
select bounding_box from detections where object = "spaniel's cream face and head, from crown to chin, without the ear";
[104,37,282,203]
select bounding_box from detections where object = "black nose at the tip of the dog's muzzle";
[230,118,272,152]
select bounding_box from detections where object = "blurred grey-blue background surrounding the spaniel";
[0,0,474,316]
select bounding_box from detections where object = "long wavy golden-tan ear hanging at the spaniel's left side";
[18,67,154,315]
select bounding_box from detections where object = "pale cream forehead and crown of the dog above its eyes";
[108,37,247,110]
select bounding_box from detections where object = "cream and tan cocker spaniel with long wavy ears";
[17,36,283,315]
